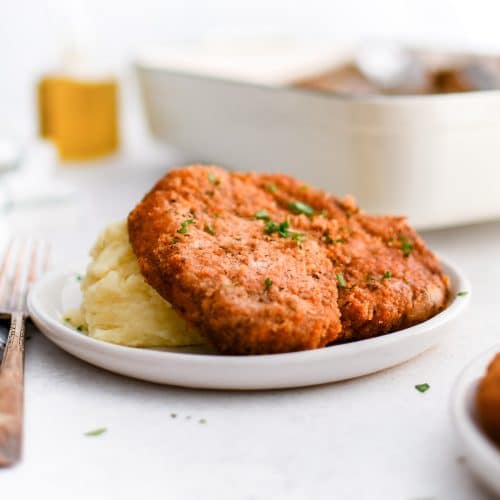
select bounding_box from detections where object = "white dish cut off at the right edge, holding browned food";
[451,344,500,495]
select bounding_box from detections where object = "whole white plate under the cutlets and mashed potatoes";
[28,264,470,390]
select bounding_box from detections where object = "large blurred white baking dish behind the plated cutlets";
[137,46,500,229]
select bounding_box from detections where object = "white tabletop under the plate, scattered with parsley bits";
[0,154,500,500]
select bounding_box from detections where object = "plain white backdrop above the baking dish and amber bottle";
[0,0,500,146]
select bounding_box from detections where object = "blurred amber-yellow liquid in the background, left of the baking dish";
[38,77,118,161]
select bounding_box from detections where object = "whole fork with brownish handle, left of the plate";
[0,240,49,466]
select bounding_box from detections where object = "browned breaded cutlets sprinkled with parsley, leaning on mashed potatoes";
[128,165,448,354]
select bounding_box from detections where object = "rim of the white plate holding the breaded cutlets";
[27,257,472,366]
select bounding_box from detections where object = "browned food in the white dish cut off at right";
[476,353,500,445]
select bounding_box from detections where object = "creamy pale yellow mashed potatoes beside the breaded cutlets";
[67,221,204,347]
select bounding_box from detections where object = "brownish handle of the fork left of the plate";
[0,312,26,466]
